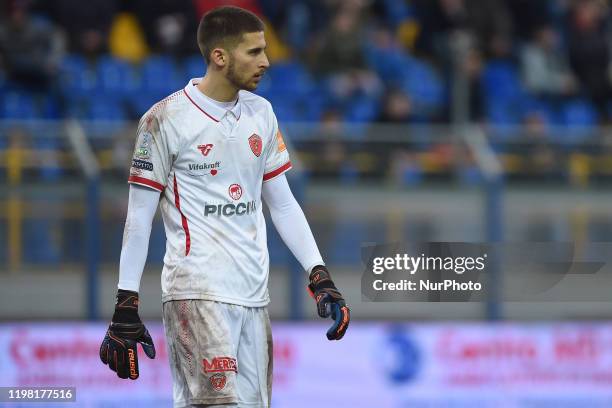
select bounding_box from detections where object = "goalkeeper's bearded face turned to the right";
[226,31,270,91]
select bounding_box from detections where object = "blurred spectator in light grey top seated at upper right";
[521,26,576,101]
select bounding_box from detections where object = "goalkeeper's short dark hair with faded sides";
[198,6,264,64]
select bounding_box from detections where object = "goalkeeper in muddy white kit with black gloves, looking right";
[100,7,350,407]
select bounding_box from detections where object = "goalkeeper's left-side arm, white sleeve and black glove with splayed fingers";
[100,185,159,380]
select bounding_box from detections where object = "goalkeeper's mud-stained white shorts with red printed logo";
[163,300,272,408]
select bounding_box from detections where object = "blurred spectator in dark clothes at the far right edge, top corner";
[567,0,610,119]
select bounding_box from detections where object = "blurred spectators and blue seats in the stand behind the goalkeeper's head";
[0,0,612,126]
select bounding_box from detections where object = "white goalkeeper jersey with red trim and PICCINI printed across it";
[128,79,291,306]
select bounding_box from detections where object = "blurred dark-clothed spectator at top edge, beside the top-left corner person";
[49,0,117,58]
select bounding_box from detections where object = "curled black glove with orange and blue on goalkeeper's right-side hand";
[308,265,351,340]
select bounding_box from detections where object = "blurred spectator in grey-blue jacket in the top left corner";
[0,0,65,92]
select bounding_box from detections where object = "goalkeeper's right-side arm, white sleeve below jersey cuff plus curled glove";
[262,174,350,340]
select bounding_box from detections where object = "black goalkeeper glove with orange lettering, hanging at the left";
[100,289,155,380]
